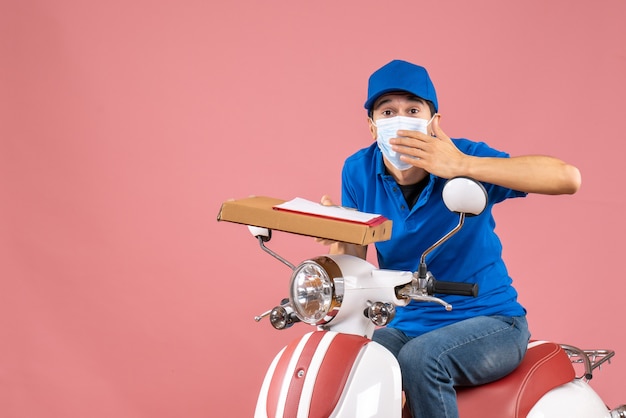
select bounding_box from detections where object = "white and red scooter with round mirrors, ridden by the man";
[233,178,626,418]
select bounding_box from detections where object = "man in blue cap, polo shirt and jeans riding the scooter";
[322,60,581,418]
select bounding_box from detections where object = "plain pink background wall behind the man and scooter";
[0,0,626,418]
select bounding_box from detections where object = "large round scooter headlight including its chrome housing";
[289,257,343,325]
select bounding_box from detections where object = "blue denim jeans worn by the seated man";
[373,316,530,418]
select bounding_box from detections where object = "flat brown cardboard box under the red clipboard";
[217,196,392,245]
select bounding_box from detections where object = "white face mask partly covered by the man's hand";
[372,116,435,170]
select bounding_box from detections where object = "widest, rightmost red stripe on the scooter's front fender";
[308,334,370,418]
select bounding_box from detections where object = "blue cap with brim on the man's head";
[364,60,439,112]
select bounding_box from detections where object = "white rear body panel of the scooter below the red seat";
[527,379,611,418]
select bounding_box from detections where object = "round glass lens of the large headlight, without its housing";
[289,261,334,324]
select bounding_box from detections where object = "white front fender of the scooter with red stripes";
[255,331,402,418]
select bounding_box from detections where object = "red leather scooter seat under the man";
[450,341,575,418]
